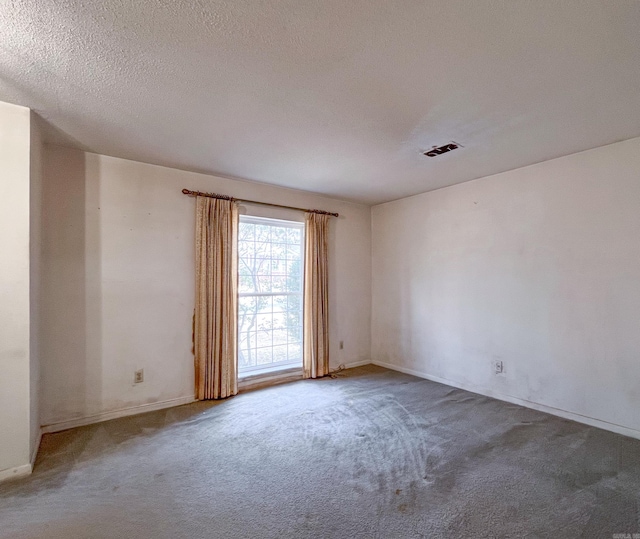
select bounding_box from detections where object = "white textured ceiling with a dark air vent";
[0,0,640,204]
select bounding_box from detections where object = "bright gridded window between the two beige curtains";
[238,215,304,378]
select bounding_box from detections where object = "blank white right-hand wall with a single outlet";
[372,138,640,436]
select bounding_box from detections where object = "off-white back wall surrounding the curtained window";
[41,146,371,424]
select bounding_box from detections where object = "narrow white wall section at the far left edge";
[0,102,30,479]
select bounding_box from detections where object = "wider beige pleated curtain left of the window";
[194,196,238,400]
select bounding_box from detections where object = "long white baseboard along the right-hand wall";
[372,361,640,439]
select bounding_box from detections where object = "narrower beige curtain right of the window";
[303,213,329,378]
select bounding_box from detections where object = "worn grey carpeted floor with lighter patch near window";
[0,366,640,539]
